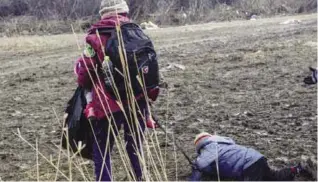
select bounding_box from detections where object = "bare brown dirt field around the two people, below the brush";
[0,14,317,180]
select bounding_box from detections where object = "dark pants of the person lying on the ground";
[243,158,295,181]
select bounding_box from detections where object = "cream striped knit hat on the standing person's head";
[99,0,129,17]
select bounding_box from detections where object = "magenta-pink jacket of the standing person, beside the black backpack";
[74,15,130,119]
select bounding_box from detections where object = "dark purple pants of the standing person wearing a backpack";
[93,103,146,181]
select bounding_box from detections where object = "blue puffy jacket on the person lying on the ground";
[190,135,264,181]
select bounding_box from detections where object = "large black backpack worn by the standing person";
[94,23,159,100]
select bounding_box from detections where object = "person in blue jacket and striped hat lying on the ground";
[189,133,314,181]
